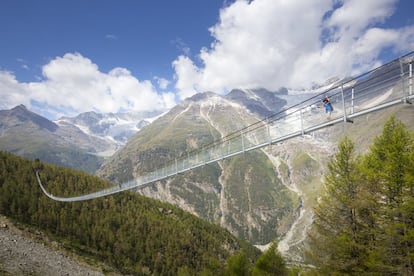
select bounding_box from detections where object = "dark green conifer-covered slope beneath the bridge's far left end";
[0,152,260,275]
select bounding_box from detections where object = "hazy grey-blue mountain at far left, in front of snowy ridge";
[0,105,114,173]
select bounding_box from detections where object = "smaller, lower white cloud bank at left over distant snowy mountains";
[0,53,175,118]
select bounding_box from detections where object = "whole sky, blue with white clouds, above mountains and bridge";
[0,0,414,119]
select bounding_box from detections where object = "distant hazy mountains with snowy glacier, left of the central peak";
[0,105,165,173]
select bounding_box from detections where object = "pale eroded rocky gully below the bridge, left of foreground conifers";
[269,135,335,262]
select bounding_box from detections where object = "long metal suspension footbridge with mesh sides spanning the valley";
[36,52,414,202]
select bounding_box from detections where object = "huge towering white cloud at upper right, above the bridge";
[173,0,414,98]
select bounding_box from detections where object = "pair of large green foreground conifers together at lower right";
[309,116,414,275]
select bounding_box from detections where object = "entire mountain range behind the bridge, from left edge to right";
[0,82,413,261]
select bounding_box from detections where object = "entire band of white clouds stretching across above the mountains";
[0,0,414,118]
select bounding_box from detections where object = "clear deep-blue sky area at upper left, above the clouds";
[0,0,223,81]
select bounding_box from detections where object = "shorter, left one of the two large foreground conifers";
[309,137,367,274]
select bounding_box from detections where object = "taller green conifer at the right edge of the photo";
[364,116,414,275]
